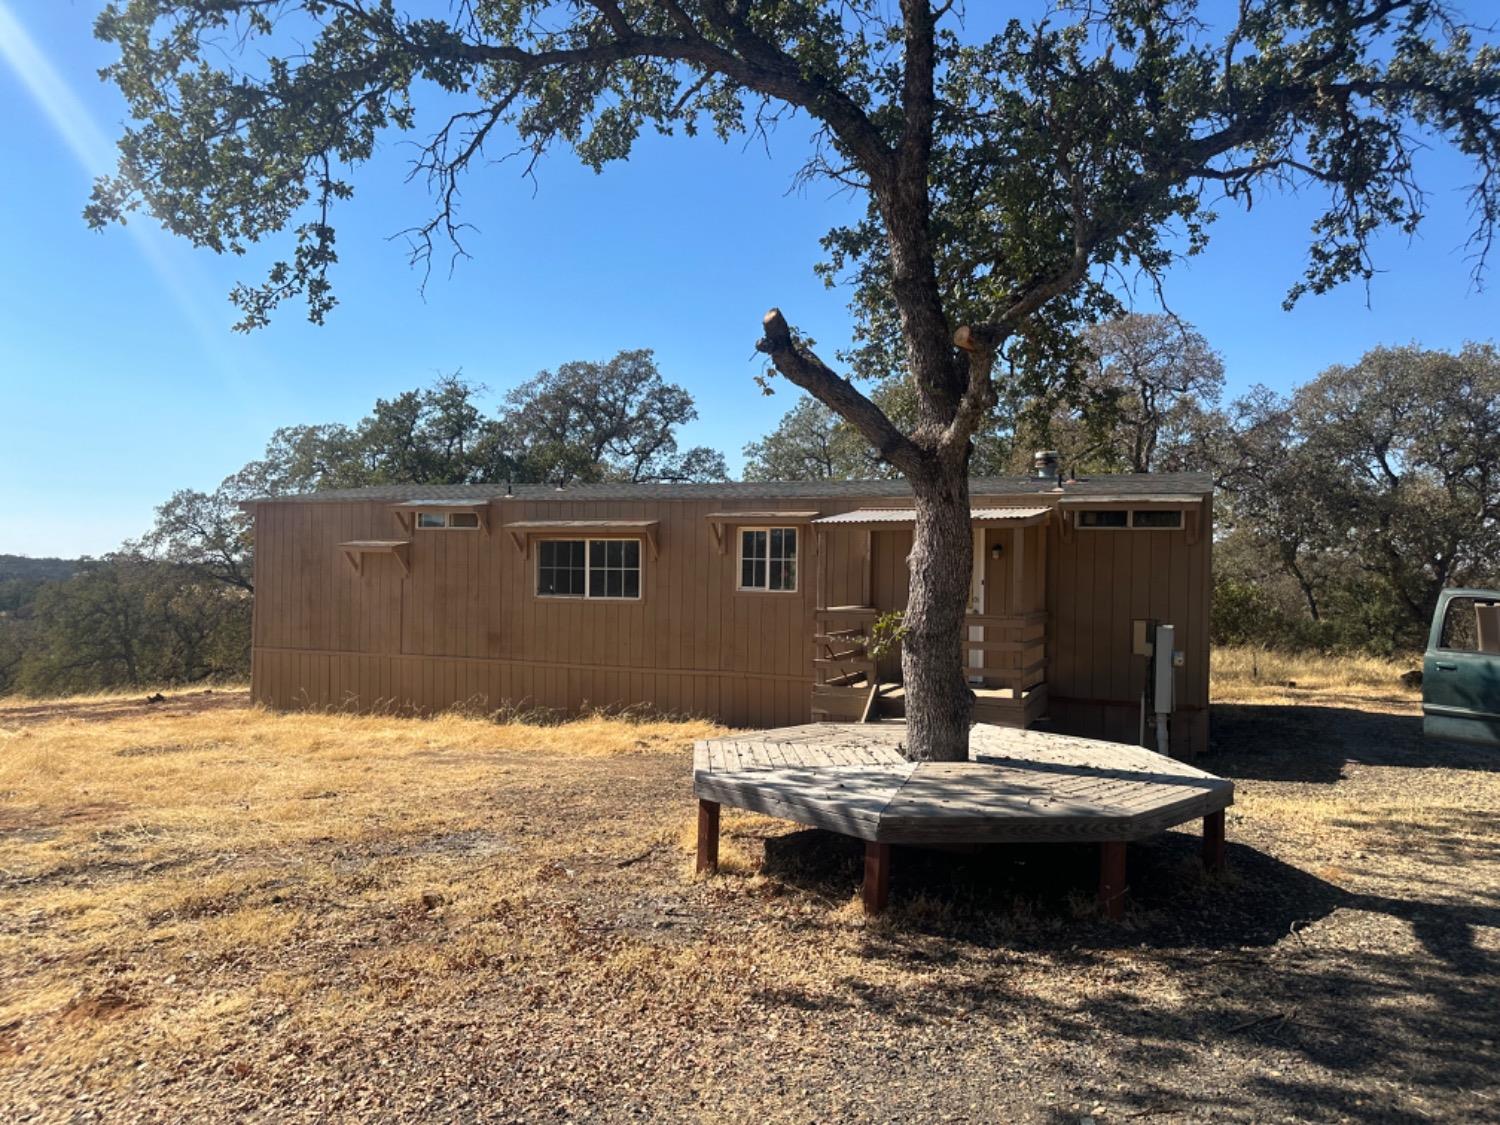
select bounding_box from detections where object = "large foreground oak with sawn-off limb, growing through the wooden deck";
[87,0,1500,759]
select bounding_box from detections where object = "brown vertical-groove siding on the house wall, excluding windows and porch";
[252,495,1212,750]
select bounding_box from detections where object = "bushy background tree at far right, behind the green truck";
[1226,344,1500,647]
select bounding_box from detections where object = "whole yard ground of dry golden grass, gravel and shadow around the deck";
[0,666,1500,1122]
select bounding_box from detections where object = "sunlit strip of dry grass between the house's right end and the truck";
[1209,645,1422,699]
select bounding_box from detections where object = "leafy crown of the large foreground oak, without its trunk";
[89,7,1497,325]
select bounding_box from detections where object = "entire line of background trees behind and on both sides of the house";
[0,330,1500,693]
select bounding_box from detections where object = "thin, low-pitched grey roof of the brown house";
[252,473,1214,506]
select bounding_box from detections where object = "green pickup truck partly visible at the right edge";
[1422,590,1500,746]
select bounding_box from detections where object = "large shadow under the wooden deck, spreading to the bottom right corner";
[762,831,1500,1122]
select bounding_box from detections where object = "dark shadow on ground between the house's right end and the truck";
[1199,704,1500,785]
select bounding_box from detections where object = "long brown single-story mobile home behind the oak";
[252,473,1214,756]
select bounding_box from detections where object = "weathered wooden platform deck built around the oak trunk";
[693,722,1235,915]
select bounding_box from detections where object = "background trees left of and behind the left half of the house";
[0,350,728,695]
